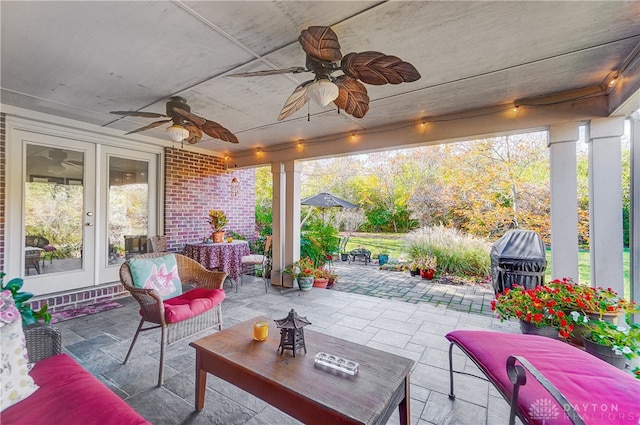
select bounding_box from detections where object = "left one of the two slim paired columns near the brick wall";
[271,162,286,286]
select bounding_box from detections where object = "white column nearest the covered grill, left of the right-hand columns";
[548,123,580,282]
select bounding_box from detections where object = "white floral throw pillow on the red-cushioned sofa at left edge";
[0,291,38,411]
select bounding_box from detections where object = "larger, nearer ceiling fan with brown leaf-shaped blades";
[230,26,420,121]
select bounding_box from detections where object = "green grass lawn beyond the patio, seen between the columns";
[347,233,631,298]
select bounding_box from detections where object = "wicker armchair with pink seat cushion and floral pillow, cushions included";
[120,252,227,386]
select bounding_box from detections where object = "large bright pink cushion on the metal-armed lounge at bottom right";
[446,330,640,425]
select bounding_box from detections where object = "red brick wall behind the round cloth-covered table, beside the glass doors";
[164,148,255,250]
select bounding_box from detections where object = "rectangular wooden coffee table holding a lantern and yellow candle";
[190,317,414,425]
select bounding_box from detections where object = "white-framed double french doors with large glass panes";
[5,129,159,295]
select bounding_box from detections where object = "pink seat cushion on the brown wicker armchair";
[164,288,226,323]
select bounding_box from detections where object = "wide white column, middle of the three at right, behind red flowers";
[588,117,624,294]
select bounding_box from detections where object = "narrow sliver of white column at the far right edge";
[629,109,640,323]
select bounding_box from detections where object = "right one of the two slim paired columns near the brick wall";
[282,160,301,288]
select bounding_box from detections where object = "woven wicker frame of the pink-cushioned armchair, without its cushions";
[120,252,227,386]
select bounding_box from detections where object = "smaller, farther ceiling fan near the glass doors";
[111,96,238,144]
